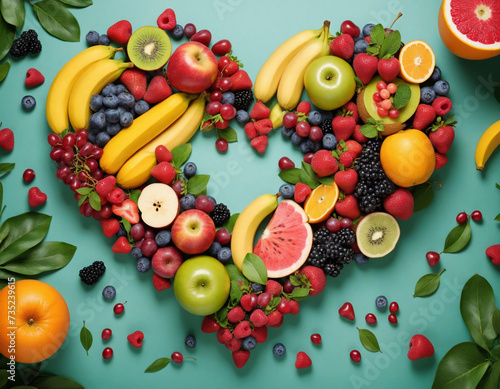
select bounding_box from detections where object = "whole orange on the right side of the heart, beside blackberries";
[380,129,436,188]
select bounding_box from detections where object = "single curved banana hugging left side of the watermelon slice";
[231,193,278,270]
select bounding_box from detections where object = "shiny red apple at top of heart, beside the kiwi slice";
[167,42,218,93]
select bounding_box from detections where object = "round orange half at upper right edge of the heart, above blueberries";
[399,41,436,84]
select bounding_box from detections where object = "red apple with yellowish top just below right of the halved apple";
[171,209,215,254]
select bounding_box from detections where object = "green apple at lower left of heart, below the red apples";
[174,255,231,316]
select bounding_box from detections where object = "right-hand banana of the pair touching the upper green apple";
[278,22,330,110]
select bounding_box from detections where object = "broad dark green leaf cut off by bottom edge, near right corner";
[432,342,491,389]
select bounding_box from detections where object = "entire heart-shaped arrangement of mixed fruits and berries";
[46,9,454,367]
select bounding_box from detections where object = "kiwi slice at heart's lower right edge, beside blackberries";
[356,212,400,258]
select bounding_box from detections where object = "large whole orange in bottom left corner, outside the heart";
[0,280,69,363]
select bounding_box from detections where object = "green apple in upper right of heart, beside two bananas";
[304,55,356,111]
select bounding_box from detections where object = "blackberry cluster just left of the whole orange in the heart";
[354,139,396,213]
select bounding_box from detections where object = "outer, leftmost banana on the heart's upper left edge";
[45,45,123,134]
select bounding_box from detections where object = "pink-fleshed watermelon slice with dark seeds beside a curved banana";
[253,200,313,278]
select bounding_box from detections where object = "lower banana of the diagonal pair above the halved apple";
[116,95,205,189]
